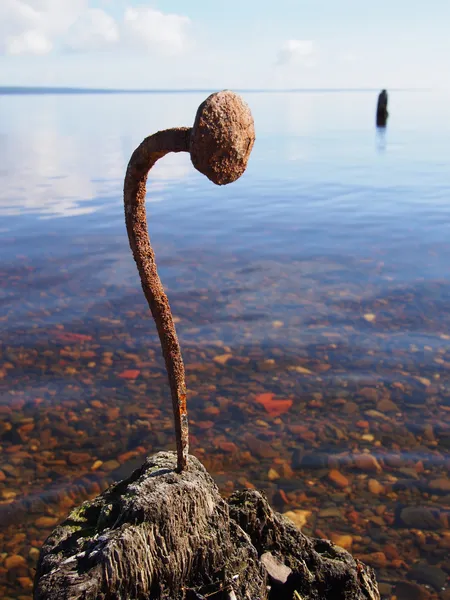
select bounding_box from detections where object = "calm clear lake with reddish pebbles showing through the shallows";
[0,91,450,600]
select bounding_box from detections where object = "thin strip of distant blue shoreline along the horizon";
[0,85,431,96]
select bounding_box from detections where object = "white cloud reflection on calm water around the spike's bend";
[0,98,192,220]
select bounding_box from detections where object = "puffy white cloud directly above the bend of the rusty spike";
[124,6,190,54]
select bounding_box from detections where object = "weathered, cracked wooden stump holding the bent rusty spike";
[34,452,379,600]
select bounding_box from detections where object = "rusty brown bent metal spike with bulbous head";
[124,91,255,471]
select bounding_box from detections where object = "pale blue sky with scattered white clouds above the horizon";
[0,0,450,88]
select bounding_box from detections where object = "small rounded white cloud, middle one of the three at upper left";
[65,8,119,52]
